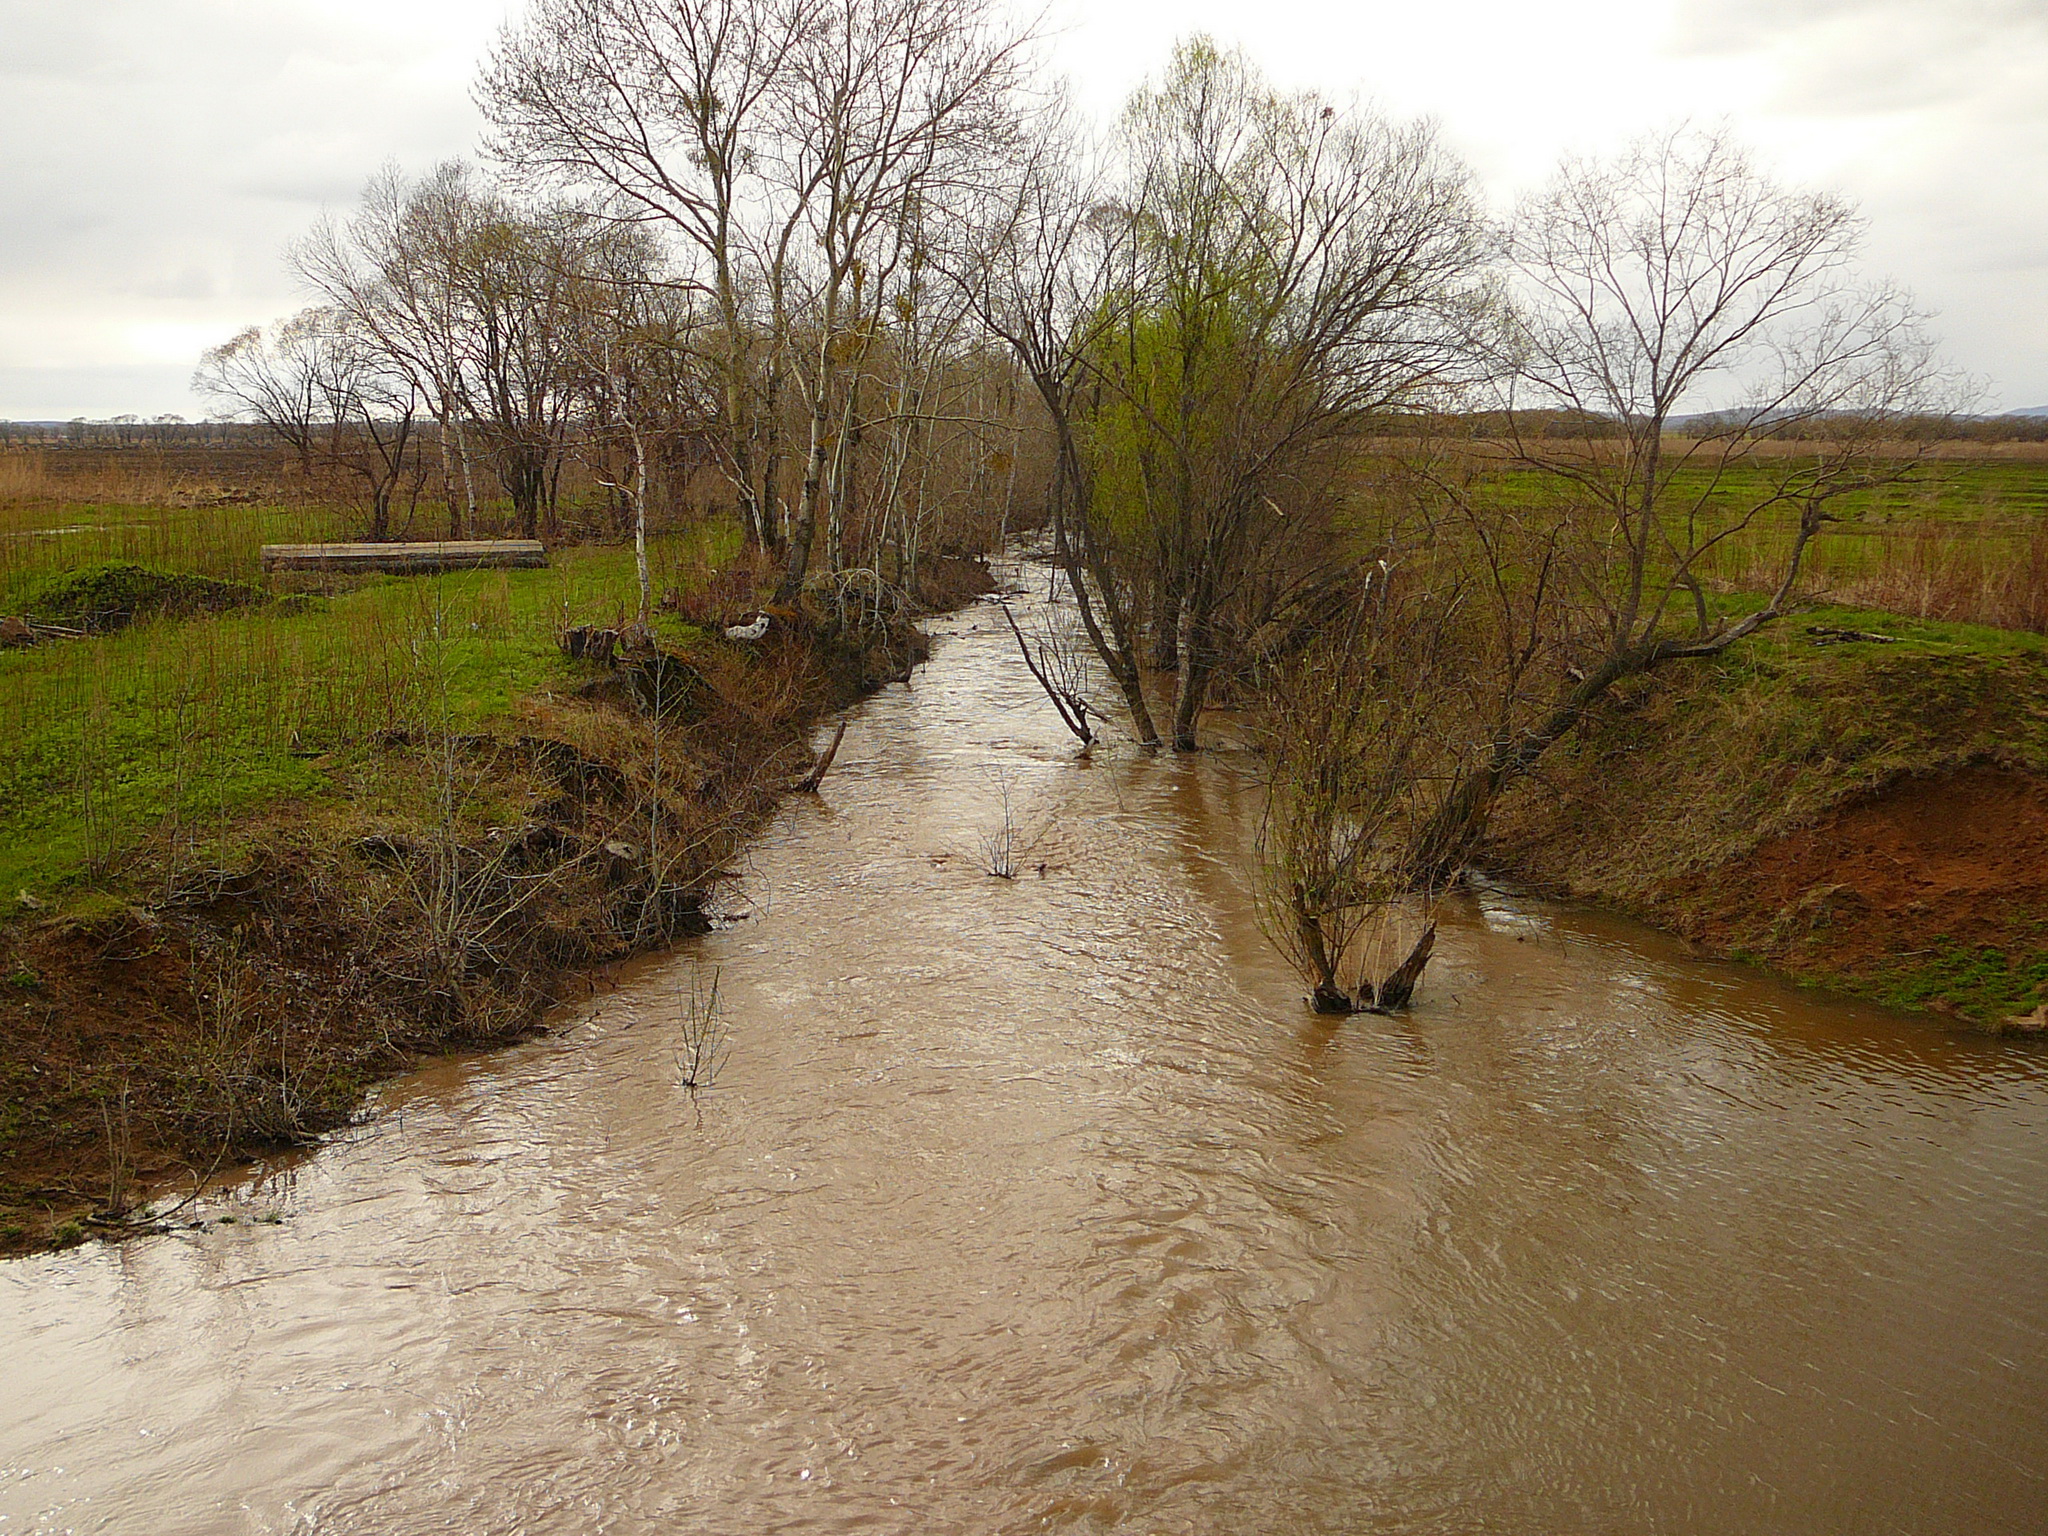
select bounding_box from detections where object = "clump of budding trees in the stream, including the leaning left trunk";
[956,39,1485,750]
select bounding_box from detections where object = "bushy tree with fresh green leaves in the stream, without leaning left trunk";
[1087,39,1485,750]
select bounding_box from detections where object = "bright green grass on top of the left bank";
[0,508,739,897]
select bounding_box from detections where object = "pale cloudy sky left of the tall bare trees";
[0,0,498,414]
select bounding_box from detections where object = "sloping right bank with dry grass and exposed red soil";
[1493,621,2048,1028]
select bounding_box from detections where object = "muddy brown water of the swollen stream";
[0,577,2048,1536]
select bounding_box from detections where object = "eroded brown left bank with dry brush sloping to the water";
[0,561,987,1253]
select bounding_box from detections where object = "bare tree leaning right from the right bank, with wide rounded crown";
[1415,131,1960,879]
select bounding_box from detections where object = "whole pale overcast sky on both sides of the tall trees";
[0,0,2048,420]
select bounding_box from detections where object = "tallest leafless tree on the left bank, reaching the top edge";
[481,0,1040,598]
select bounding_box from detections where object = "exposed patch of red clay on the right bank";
[1665,766,2048,975]
